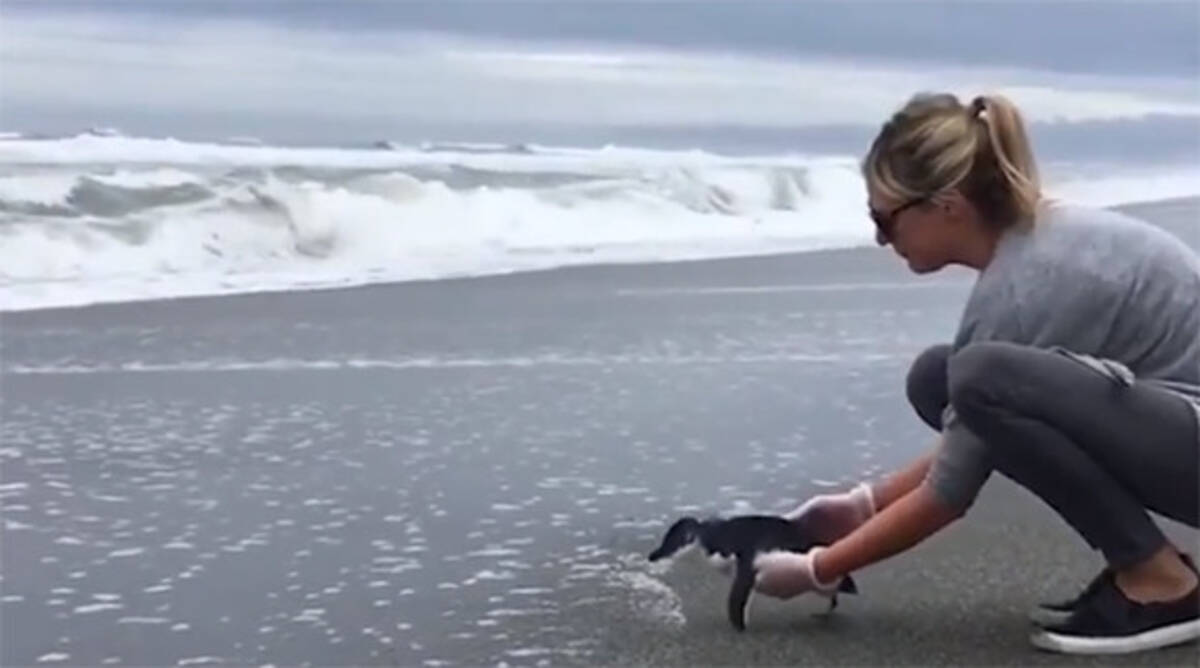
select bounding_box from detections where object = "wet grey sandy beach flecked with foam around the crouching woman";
[0,199,1200,666]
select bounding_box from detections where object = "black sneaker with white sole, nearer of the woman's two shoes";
[1030,577,1200,654]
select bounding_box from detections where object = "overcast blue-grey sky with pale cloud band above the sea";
[0,0,1200,142]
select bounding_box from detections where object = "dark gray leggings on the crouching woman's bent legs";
[908,343,1200,567]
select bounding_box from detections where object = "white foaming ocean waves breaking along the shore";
[0,134,1200,309]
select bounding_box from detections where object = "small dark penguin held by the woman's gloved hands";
[648,514,858,631]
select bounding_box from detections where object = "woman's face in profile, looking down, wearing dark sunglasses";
[868,188,958,273]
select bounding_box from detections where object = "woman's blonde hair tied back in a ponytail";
[863,92,1042,228]
